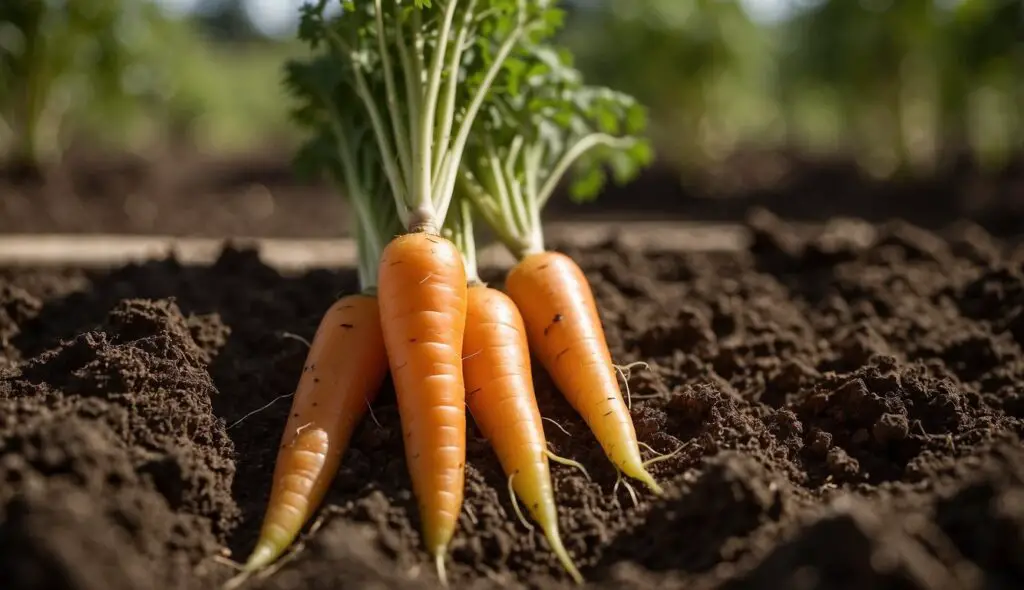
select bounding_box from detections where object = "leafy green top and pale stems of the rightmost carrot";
[458,45,652,257]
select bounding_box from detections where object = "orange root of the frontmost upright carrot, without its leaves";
[377,233,467,560]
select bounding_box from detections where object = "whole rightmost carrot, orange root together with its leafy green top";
[459,46,664,495]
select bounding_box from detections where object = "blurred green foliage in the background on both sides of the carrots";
[0,0,1024,180]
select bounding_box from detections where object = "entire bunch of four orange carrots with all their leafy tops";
[230,0,666,583]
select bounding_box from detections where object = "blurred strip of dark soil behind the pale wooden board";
[6,148,1024,238]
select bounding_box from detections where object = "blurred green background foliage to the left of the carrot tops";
[0,0,298,170]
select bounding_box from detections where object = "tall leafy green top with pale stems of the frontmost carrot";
[299,0,558,234]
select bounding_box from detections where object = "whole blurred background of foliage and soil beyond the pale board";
[0,0,1024,237]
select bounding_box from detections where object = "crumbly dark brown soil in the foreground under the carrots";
[0,211,1024,590]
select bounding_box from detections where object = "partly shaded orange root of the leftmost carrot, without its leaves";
[246,294,387,570]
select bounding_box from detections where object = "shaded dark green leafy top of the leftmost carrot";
[285,54,400,293]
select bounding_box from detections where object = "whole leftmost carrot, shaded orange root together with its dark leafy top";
[231,45,399,584]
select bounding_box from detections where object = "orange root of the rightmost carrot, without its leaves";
[505,251,662,494]
